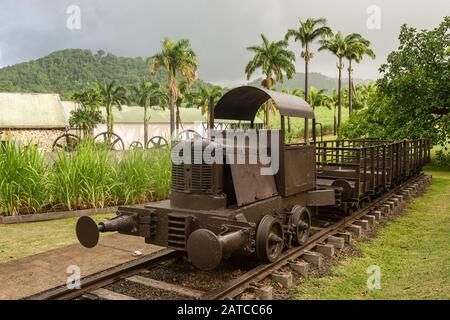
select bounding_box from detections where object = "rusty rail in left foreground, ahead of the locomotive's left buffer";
[25,249,178,300]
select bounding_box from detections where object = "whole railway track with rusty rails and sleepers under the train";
[27,175,431,300]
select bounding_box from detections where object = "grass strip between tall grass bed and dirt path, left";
[0,214,113,263]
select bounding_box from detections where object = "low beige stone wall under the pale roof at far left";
[0,129,65,152]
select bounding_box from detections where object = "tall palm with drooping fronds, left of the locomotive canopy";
[148,38,198,138]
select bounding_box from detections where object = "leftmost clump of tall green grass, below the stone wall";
[0,141,48,215]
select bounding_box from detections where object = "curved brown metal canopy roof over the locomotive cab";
[214,86,314,121]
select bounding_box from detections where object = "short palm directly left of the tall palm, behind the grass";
[131,79,166,147]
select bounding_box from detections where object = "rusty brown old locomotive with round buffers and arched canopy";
[77,86,335,270]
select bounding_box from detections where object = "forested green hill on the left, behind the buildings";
[0,49,208,98]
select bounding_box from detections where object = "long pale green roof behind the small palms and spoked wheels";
[62,101,262,124]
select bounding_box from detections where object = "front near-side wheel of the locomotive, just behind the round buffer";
[256,215,284,262]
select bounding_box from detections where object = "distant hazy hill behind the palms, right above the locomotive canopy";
[249,72,371,91]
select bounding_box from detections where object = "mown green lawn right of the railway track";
[292,168,450,300]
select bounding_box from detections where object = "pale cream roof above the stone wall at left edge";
[0,93,67,129]
